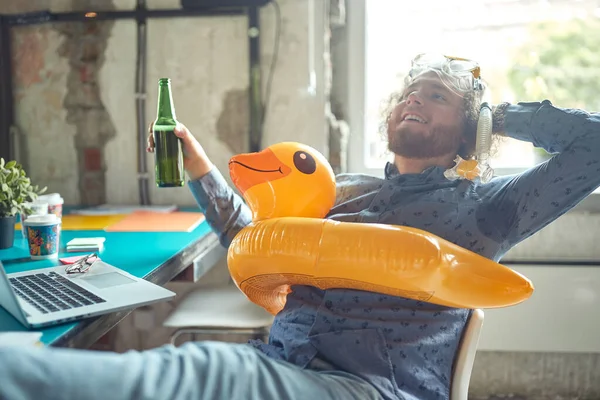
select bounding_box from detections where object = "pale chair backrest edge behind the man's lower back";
[450,309,483,400]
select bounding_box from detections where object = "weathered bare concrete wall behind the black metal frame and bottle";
[0,0,328,205]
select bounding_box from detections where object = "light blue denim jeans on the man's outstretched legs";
[0,342,381,400]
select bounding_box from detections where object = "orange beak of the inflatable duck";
[229,149,292,194]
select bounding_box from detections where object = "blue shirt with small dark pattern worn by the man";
[190,101,600,400]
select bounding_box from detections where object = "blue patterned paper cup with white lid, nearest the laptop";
[25,214,61,260]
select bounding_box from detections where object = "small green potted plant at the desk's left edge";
[0,157,46,249]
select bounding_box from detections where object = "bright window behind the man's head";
[348,0,600,176]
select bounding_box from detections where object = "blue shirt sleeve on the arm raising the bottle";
[189,168,252,248]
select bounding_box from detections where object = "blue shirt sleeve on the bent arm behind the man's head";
[480,100,600,245]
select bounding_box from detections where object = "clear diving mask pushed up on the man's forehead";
[408,53,484,92]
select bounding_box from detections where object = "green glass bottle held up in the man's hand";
[153,78,185,187]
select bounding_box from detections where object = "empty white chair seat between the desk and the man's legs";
[163,284,273,345]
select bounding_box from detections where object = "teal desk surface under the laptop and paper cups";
[0,212,220,348]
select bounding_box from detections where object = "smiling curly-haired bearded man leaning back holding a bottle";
[0,57,600,400]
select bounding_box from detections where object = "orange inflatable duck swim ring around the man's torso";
[227,142,533,314]
